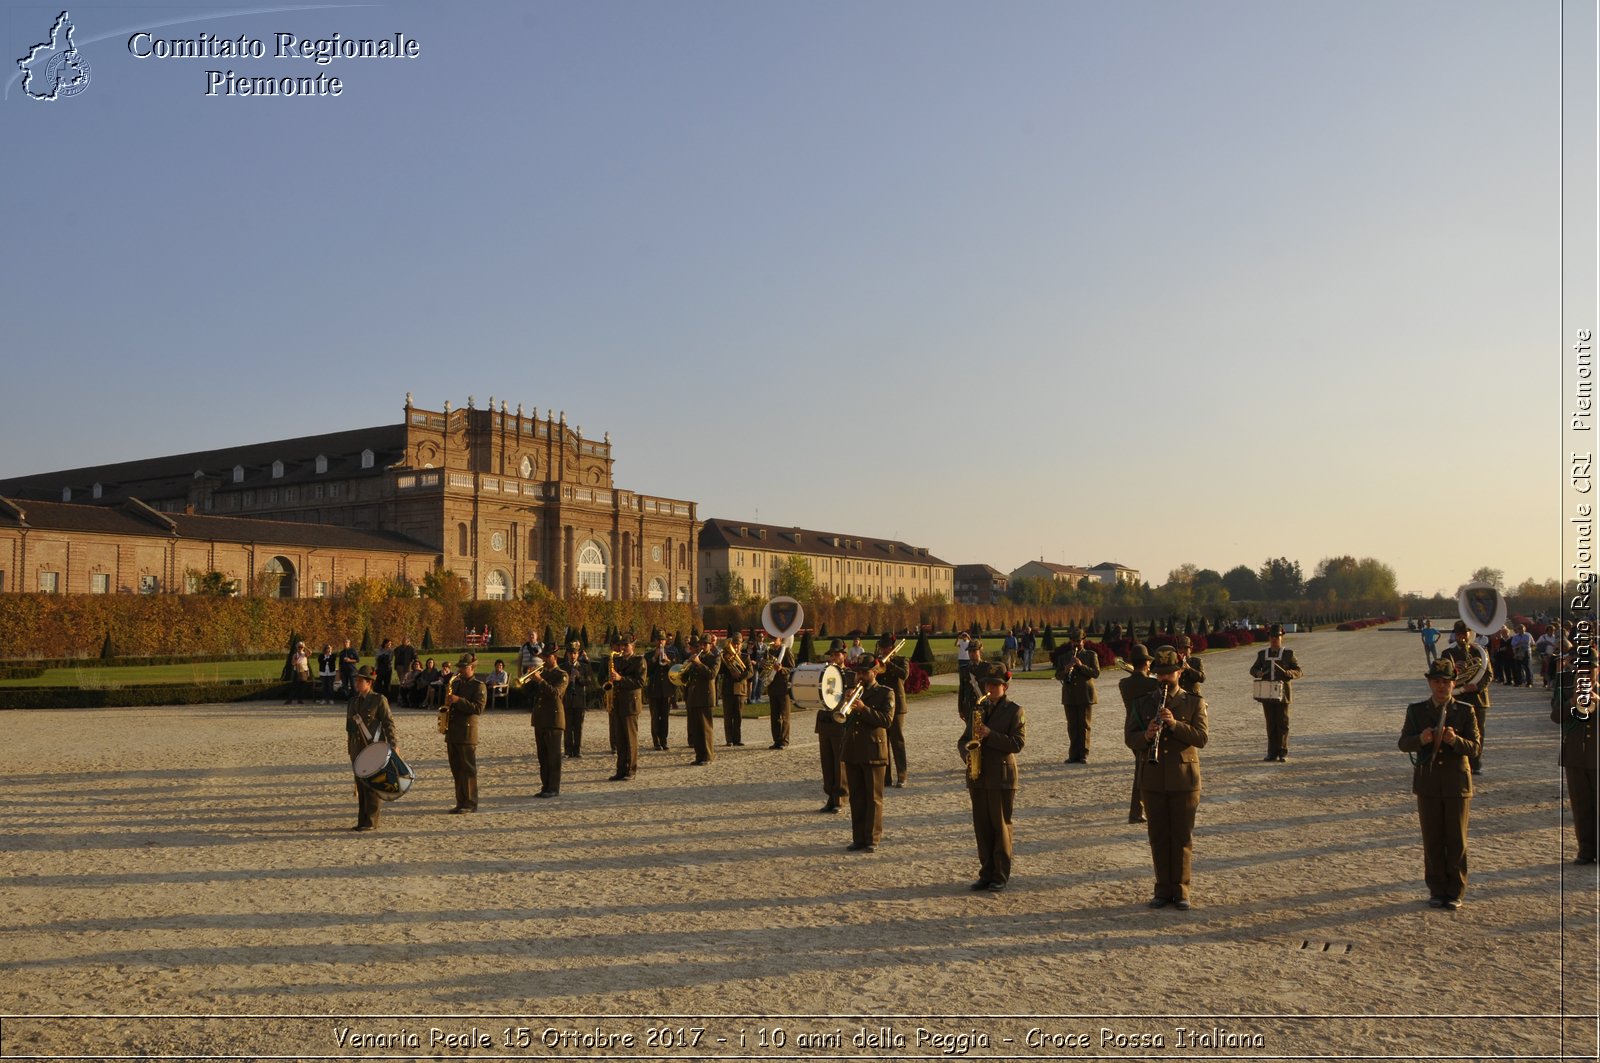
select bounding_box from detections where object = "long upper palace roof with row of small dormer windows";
[0,424,406,506]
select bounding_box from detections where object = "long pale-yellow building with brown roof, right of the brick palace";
[696,519,955,602]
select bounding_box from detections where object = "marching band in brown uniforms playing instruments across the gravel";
[337,599,1600,911]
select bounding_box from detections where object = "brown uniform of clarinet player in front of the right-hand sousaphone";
[1400,697,1482,903]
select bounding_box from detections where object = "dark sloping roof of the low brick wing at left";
[0,496,438,554]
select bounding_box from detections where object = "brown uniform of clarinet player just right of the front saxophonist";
[1125,672,1210,908]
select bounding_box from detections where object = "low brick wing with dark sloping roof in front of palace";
[0,498,438,597]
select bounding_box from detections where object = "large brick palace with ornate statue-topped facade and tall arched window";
[0,392,701,602]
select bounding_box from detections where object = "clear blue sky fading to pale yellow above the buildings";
[0,0,1565,594]
